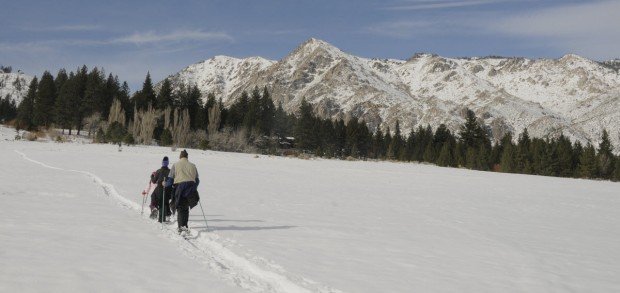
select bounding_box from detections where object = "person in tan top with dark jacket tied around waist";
[166,150,200,234]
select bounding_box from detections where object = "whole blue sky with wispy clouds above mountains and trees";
[0,0,620,91]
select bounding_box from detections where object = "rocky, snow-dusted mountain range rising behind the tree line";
[159,39,620,145]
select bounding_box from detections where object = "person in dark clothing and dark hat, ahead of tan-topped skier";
[150,157,172,223]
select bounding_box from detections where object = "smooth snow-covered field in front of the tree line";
[0,128,620,292]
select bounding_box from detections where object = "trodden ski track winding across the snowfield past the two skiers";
[14,150,342,293]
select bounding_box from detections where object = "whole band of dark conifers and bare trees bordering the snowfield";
[8,66,620,180]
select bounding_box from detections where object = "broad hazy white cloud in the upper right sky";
[362,0,620,60]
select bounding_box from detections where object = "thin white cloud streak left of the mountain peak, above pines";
[109,30,233,45]
